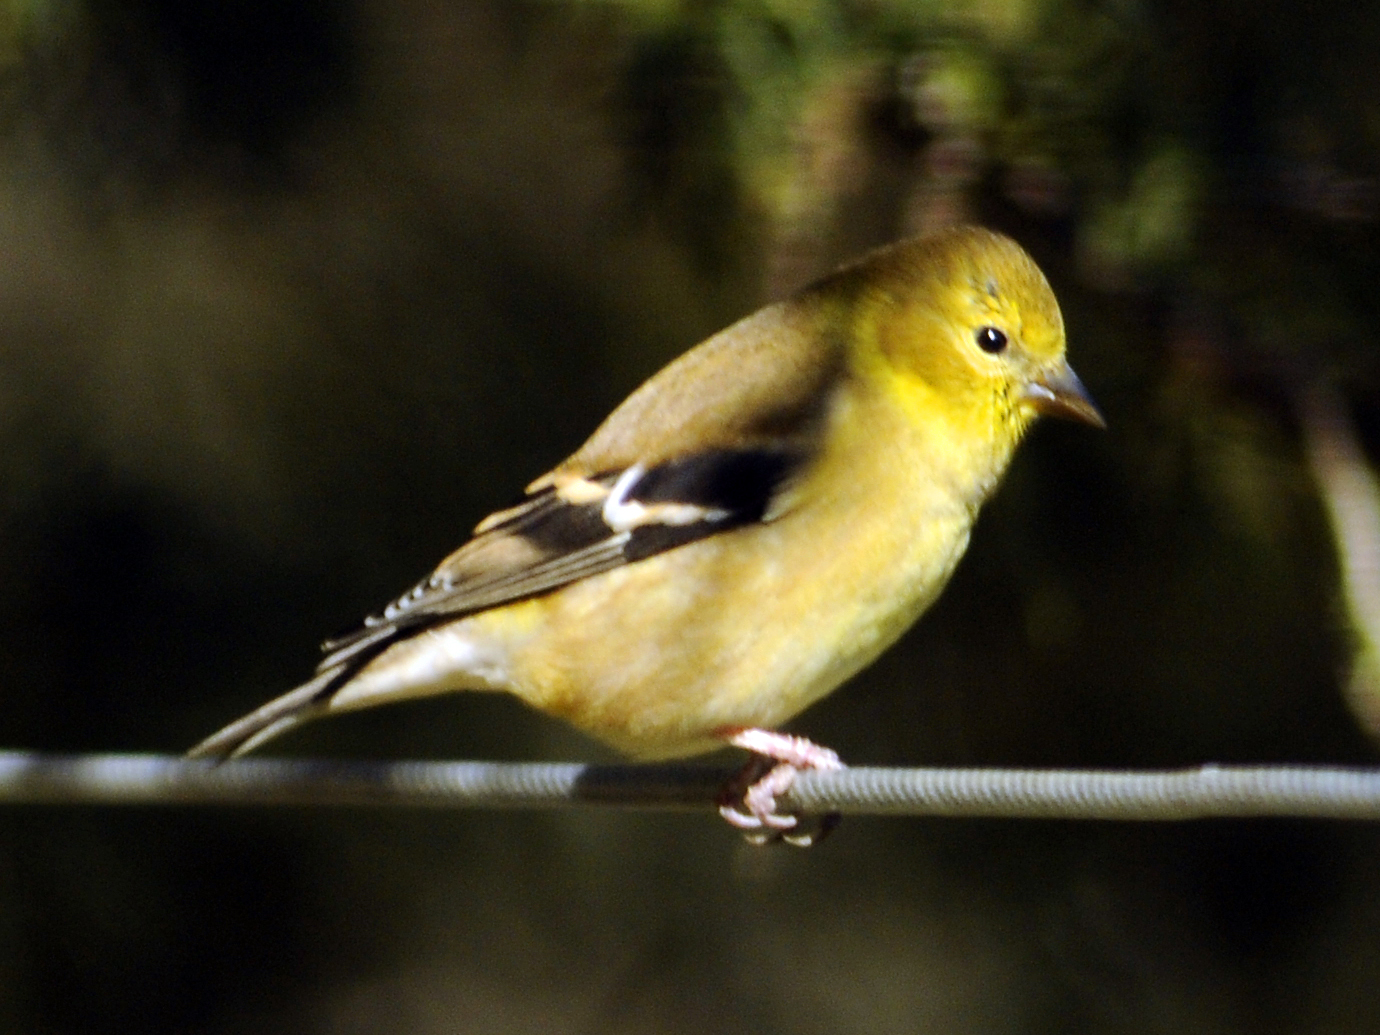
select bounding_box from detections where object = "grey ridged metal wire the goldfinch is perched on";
[0,751,1380,820]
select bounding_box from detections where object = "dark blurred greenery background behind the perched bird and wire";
[0,0,1380,1035]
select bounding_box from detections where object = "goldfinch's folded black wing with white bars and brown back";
[319,295,846,676]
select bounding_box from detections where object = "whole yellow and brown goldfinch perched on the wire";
[190,228,1103,831]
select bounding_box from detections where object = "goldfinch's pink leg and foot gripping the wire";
[719,729,843,847]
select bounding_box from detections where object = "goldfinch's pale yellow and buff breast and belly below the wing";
[480,364,985,758]
